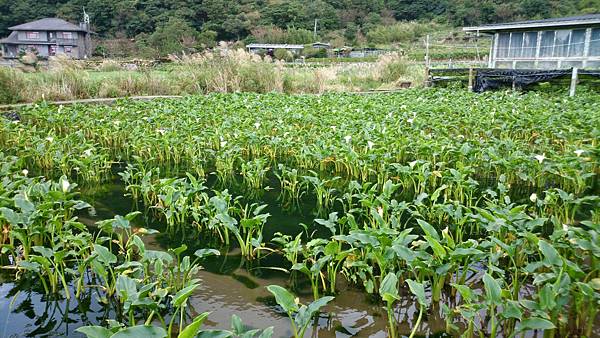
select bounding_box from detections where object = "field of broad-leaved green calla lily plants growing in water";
[0,89,600,337]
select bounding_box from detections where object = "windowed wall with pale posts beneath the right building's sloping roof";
[489,27,600,69]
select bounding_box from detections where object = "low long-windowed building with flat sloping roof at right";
[463,14,600,69]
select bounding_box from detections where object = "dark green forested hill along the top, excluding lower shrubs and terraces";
[0,0,600,49]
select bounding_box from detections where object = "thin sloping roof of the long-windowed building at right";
[463,14,600,33]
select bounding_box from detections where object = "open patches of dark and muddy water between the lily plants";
[0,176,600,338]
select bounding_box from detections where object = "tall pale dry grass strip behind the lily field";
[0,51,424,104]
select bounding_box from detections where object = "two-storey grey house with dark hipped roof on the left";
[0,18,92,59]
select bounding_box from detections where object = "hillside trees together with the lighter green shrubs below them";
[0,0,600,57]
